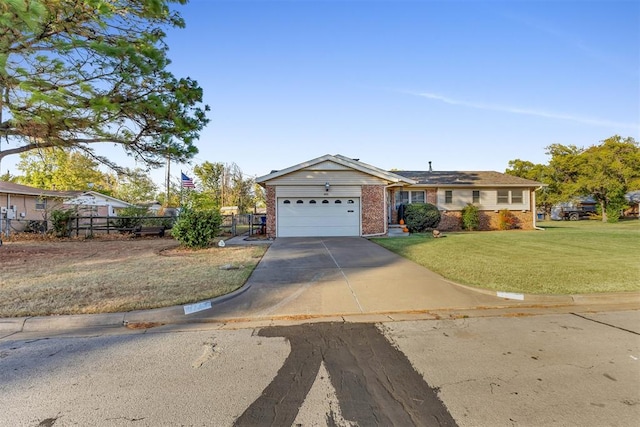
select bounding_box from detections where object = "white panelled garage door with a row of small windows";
[277,197,360,237]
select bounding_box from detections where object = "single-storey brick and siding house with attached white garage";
[256,154,542,237]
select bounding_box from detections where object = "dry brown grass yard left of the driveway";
[0,239,266,317]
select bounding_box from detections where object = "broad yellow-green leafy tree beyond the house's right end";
[506,135,640,222]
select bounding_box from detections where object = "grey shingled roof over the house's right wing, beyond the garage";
[394,171,544,187]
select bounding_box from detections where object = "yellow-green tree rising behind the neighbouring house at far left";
[17,148,116,195]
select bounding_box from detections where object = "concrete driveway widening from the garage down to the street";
[190,237,505,319]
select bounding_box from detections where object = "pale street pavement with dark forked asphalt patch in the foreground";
[0,311,640,426]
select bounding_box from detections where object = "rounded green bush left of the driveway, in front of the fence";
[171,208,222,248]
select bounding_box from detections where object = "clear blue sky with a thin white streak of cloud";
[3,0,640,182]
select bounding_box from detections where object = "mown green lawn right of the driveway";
[373,220,640,294]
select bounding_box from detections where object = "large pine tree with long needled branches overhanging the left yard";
[0,0,208,169]
